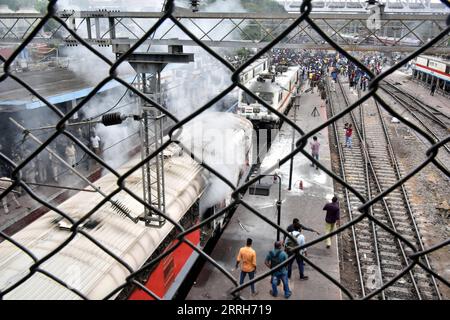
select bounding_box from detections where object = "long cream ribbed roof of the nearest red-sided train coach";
[0,155,207,299]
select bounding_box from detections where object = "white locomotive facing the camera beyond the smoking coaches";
[236,65,300,128]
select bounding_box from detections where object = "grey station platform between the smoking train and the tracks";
[187,89,342,300]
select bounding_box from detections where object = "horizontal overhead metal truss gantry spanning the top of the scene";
[0,8,449,53]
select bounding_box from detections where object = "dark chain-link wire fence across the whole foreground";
[0,0,450,299]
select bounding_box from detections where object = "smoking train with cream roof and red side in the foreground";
[0,112,253,300]
